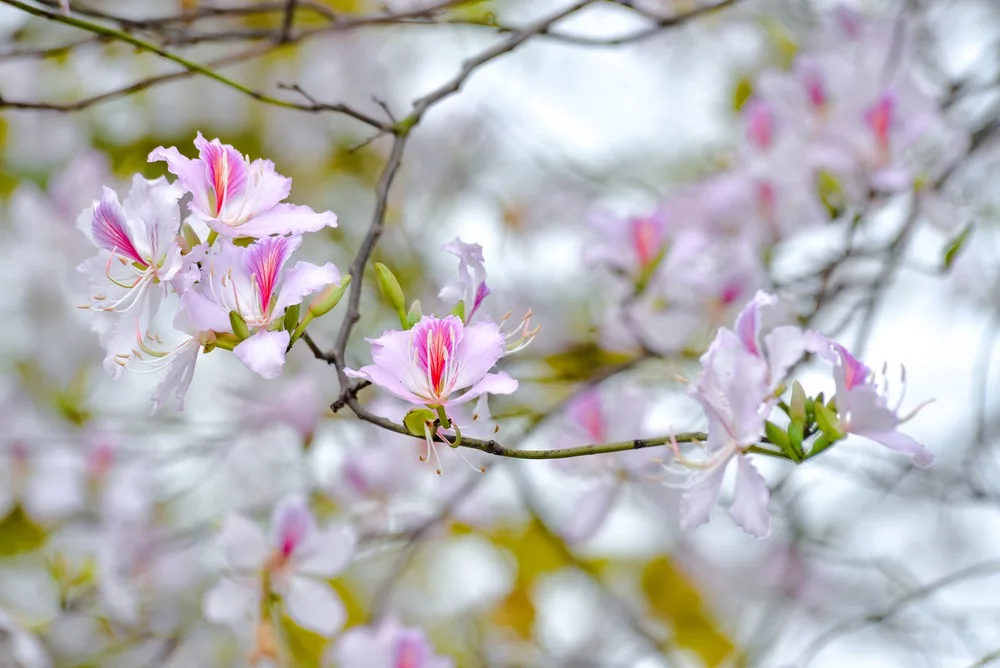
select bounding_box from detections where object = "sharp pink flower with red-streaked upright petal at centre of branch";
[347,315,517,407]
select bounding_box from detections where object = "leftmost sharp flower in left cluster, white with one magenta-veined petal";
[77,176,184,375]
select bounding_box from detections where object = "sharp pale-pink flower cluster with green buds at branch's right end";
[672,292,934,537]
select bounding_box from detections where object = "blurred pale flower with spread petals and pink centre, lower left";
[202,496,355,636]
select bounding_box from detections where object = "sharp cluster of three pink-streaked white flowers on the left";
[78,133,341,409]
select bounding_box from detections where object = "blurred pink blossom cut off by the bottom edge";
[333,617,455,668]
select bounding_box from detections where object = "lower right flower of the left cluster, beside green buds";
[184,236,340,378]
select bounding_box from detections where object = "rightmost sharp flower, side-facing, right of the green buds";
[807,332,934,468]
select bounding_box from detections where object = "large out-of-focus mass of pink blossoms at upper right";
[587,8,969,353]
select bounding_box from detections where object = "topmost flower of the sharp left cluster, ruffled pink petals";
[149,132,337,238]
